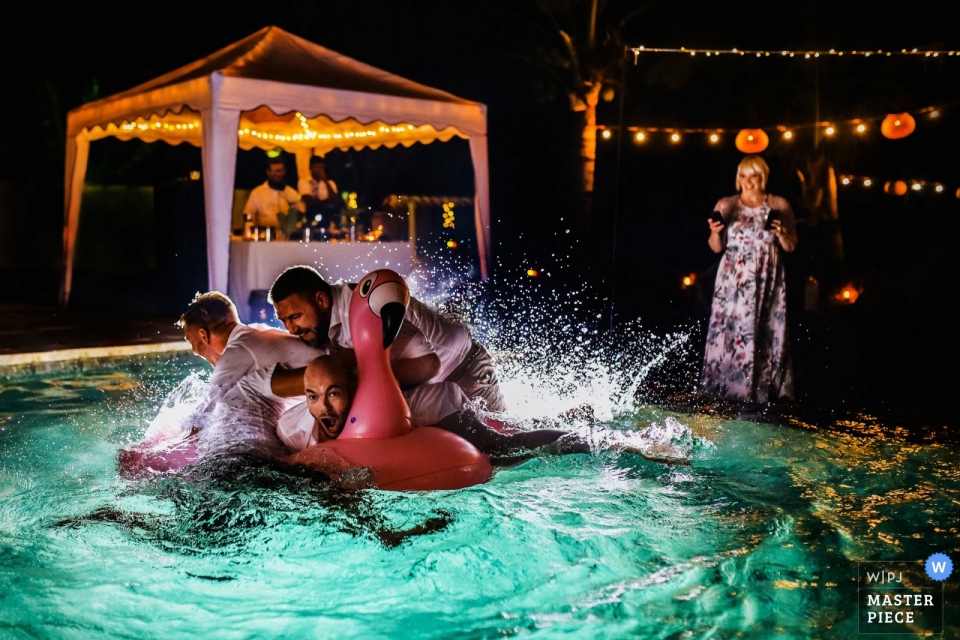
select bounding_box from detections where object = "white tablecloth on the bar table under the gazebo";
[227,241,413,322]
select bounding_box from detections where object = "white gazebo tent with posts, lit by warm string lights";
[61,27,490,304]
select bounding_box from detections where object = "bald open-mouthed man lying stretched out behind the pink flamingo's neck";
[272,355,682,464]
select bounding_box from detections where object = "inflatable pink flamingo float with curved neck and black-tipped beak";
[291,269,493,491]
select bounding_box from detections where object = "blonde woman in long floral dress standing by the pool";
[700,156,797,402]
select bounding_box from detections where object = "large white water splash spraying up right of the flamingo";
[411,255,696,422]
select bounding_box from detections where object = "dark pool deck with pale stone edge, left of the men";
[0,303,190,378]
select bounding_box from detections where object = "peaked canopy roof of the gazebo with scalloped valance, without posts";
[68,27,486,154]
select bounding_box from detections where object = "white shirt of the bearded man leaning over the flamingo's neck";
[328,282,473,383]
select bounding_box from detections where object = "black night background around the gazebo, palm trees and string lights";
[0,0,960,422]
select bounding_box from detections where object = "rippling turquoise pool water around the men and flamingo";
[0,363,960,638]
